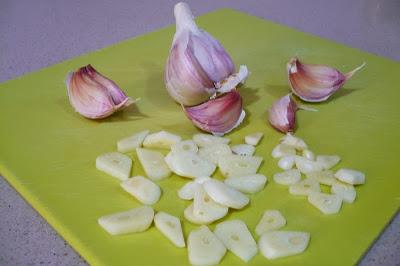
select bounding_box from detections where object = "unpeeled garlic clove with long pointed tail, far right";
[286,58,365,102]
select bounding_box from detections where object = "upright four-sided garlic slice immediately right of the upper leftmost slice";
[136,148,171,181]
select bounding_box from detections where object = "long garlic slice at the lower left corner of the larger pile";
[98,206,154,235]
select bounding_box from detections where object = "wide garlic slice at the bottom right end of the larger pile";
[258,231,310,260]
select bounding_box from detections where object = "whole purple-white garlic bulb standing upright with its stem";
[165,3,248,106]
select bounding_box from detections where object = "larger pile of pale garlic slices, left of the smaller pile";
[96,130,310,265]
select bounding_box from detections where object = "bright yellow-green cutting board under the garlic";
[0,10,400,265]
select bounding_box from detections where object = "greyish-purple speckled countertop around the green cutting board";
[0,0,400,265]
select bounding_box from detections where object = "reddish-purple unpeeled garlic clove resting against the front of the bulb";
[183,90,246,136]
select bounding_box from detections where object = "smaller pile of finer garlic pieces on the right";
[272,134,365,214]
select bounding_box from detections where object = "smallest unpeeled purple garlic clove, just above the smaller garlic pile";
[268,94,297,133]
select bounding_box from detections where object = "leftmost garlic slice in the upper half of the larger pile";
[96,152,132,180]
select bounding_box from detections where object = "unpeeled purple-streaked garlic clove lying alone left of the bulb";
[66,65,134,119]
